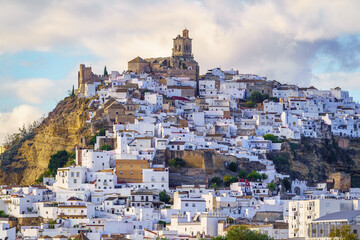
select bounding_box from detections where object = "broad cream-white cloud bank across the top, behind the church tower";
[0,0,360,82]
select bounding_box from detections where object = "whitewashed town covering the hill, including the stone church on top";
[0,29,360,240]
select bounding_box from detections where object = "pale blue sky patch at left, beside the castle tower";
[0,48,99,113]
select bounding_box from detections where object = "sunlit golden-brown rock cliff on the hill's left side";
[0,96,90,185]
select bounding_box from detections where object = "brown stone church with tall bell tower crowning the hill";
[128,29,199,89]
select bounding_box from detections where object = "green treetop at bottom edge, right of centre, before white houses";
[212,225,273,240]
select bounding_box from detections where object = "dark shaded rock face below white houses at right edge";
[268,138,360,182]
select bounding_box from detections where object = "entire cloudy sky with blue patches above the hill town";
[0,0,360,144]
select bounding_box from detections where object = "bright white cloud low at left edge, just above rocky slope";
[0,105,44,145]
